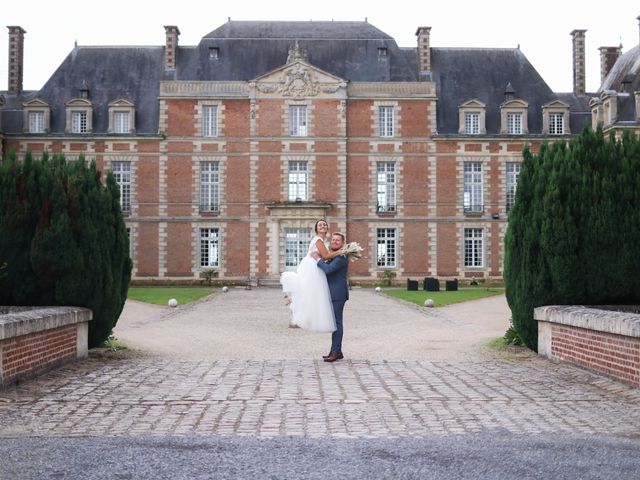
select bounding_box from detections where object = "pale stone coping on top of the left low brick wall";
[0,306,93,341]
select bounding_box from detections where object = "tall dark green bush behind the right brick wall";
[504,128,640,350]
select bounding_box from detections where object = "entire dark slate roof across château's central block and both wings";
[2,21,588,135]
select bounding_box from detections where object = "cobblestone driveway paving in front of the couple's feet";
[0,288,640,438]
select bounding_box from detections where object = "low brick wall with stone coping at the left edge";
[0,307,92,388]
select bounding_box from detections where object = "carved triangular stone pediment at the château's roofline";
[249,60,347,99]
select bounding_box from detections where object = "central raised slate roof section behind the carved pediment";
[176,21,418,82]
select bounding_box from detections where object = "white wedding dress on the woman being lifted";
[280,236,336,332]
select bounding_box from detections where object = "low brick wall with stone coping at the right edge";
[534,305,640,387]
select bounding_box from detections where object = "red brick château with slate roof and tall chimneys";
[0,21,640,283]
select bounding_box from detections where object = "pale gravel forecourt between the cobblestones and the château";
[114,288,510,360]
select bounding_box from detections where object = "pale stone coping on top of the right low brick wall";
[533,305,640,338]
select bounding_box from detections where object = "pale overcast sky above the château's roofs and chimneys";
[0,0,640,92]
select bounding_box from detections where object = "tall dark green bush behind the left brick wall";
[0,152,131,347]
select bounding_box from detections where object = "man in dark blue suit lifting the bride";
[311,232,349,362]
